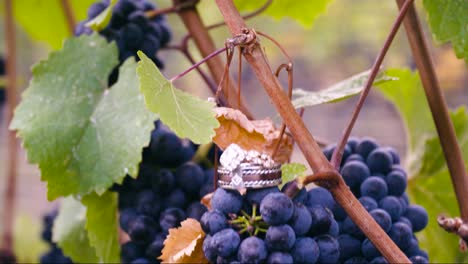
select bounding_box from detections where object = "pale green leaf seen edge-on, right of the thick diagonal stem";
[292,71,396,108]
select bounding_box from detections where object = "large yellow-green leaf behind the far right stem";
[379,67,468,263]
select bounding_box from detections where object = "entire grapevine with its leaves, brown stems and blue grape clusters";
[0,0,468,263]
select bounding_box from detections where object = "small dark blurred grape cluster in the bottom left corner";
[39,210,73,264]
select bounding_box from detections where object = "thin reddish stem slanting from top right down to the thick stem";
[331,0,414,170]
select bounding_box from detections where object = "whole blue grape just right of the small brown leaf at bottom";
[211,228,240,257]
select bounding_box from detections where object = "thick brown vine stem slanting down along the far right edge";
[396,0,468,222]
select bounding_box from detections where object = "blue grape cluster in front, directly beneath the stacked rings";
[201,185,340,264]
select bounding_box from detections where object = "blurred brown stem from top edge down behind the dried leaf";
[173,0,253,119]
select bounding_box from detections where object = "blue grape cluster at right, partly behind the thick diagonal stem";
[322,138,429,263]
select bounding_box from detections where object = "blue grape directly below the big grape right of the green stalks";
[265,225,296,251]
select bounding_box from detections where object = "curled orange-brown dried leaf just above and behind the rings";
[213,107,293,163]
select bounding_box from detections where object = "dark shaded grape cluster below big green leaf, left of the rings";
[112,124,214,263]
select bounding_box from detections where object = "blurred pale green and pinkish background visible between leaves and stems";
[0,0,468,261]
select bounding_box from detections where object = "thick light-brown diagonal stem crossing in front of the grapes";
[216,0,410,263]
